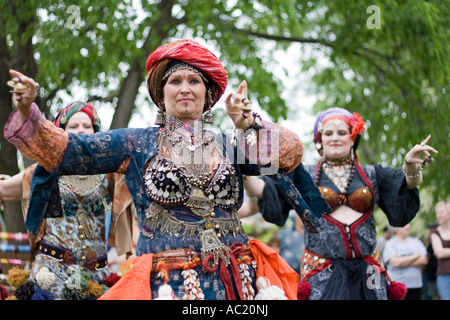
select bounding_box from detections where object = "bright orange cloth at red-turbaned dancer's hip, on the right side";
[248,240,299,300]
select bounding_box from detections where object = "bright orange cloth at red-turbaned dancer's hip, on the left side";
[99,253,153,300]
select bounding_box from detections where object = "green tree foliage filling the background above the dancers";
[0,0,450,222]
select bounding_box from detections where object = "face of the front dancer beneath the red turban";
[163,69,206,121]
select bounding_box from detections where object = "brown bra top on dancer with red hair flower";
[319,172,373,213]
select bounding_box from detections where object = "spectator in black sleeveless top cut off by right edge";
[431,201,450,300]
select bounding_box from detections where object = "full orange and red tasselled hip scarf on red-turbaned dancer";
[100,240,298,300]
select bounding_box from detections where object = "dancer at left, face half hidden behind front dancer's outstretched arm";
[0,101,134,300]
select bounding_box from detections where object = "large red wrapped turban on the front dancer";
[145,39,228,105]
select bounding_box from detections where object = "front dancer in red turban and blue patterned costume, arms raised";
[5,40,328,300]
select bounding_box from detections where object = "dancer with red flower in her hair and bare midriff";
[243,107,437,300]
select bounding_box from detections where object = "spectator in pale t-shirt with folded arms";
[383,224,428,300]
